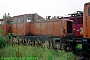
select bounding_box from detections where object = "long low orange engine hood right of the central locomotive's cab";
[32,19,73,36]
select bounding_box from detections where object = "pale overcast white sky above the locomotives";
[0,0,90,18]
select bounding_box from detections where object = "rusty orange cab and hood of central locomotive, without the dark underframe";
[12,14,73,36]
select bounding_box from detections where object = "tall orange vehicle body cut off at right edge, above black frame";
[83,2,90,38]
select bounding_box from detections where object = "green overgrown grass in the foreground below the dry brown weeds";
[0,45,75,60]
